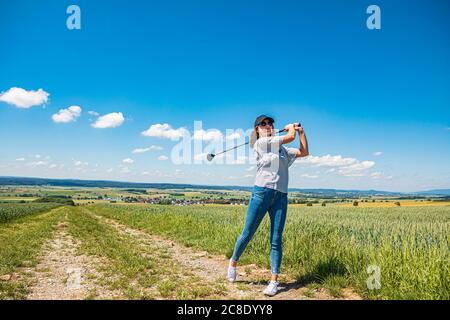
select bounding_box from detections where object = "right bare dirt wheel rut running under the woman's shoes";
[90,211,359,300]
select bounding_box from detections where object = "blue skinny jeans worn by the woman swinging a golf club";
[231,186,288,274]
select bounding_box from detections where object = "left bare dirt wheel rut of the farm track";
[23,219,114,300]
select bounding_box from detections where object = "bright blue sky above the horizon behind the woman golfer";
[0,0,450,191]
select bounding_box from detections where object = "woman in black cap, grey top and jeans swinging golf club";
[227,115,309,296]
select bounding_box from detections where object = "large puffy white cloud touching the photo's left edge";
[0,87,49,109]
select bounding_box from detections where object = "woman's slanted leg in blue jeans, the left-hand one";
[231,188,275,267]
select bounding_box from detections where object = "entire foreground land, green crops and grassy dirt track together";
[0,203,450,300]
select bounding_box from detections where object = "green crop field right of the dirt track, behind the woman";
[92,205,450,299]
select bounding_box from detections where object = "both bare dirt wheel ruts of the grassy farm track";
[20,209,359,300]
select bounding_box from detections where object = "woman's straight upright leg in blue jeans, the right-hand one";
[269,191,288,281]
